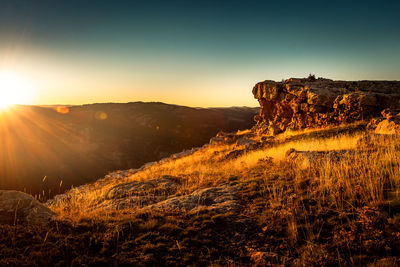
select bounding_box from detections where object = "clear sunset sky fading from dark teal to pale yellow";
[0,0,400,107]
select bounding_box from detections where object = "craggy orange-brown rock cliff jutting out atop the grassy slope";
[253,78,400,135]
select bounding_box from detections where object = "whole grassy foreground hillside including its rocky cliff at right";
[0,79,400,266]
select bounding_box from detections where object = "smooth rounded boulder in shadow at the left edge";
[0,190,55,225]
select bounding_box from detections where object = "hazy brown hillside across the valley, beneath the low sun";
[0,102,258,198]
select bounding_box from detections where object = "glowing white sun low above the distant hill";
[0,71,34,110]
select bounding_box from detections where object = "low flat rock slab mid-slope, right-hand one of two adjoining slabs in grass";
[146,185,241,213]
